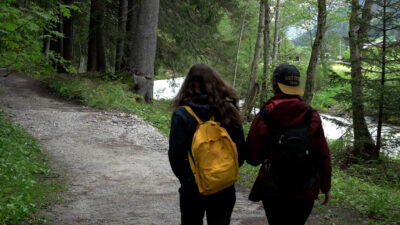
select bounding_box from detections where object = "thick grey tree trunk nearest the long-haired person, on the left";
[128,0,160,103]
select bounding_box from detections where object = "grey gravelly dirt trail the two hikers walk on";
[0,74,267,225]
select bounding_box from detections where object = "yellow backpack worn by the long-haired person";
[184,106,239,195]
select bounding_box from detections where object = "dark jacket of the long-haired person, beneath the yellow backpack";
[168,96,245,194]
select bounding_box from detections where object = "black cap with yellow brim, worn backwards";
[272,63,304,95]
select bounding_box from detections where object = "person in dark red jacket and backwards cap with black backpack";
[245,63,332,225]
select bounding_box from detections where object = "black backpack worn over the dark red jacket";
[259,106,317,195]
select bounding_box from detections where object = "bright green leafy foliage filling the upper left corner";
[0,0,78,77]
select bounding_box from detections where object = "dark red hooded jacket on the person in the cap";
[246,94,332,201]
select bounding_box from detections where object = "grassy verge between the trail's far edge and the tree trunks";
[43,75,172,136]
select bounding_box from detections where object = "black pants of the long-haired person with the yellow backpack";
[180,187,236,225]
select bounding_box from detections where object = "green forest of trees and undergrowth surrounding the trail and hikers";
[0,0,400,224]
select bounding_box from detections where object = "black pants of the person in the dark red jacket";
[262,197,314,225]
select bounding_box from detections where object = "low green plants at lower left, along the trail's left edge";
[0,112,61,224]
